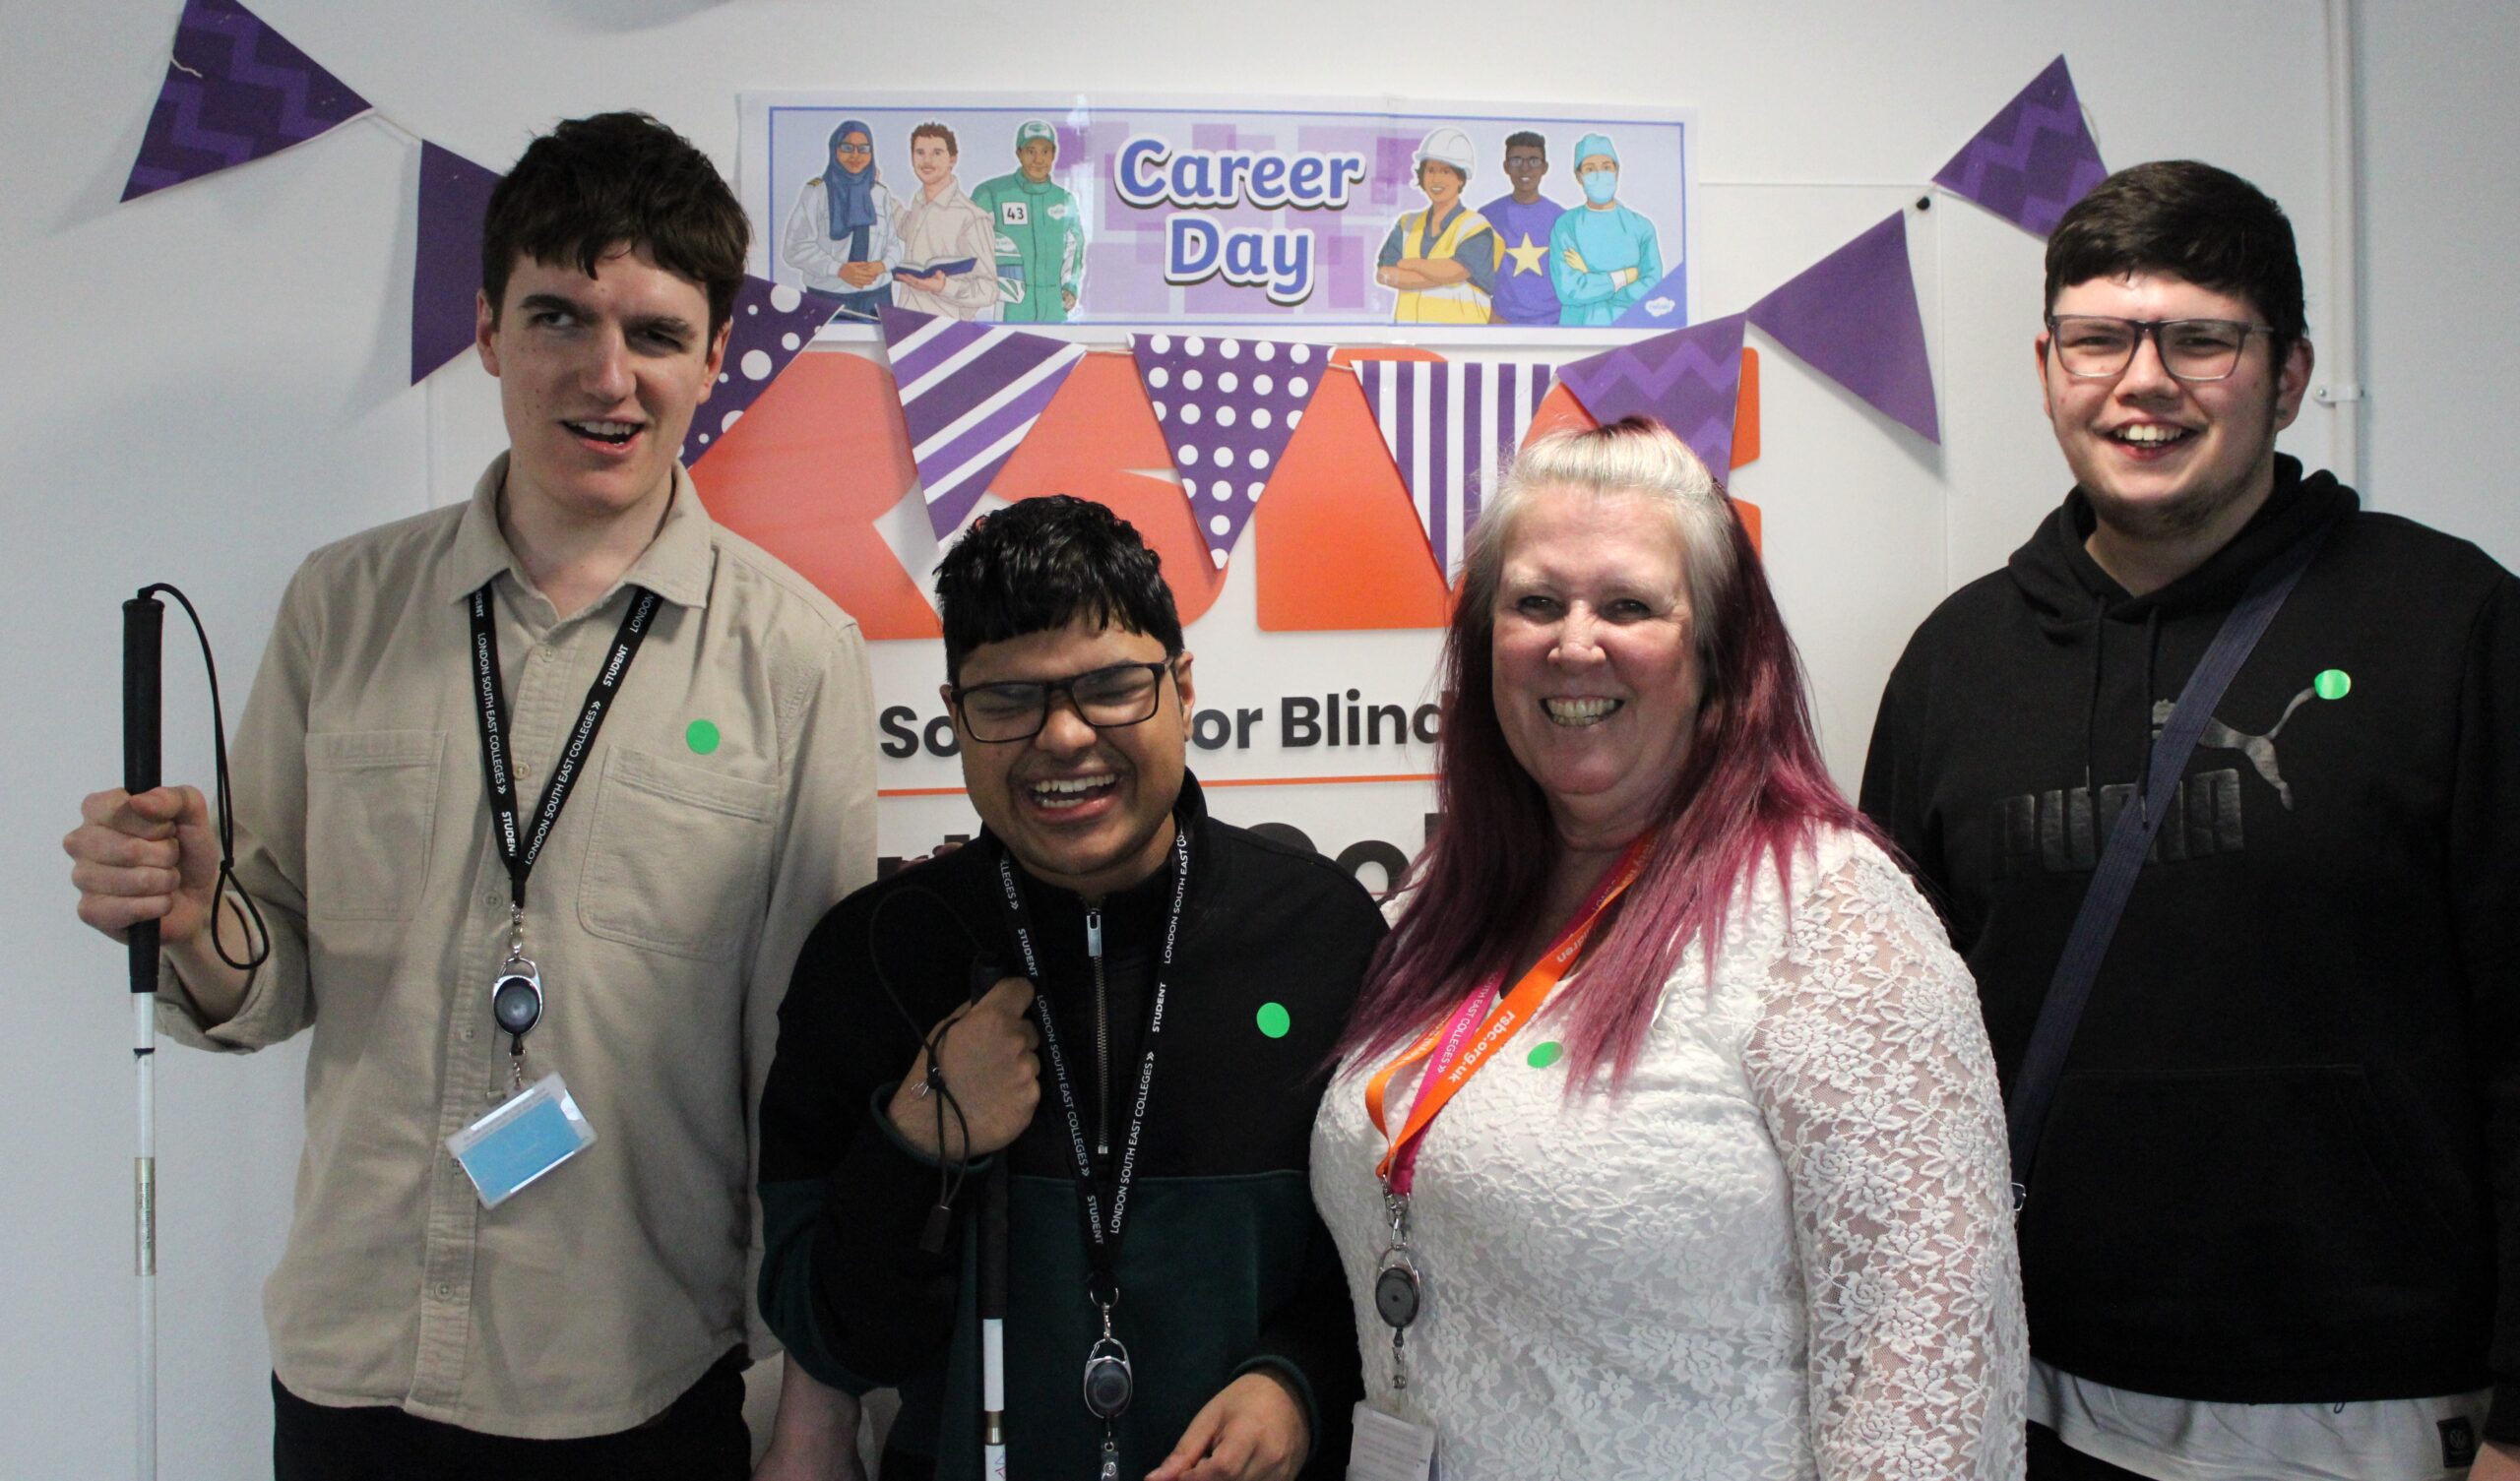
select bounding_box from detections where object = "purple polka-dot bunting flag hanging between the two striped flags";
[1129,335,1331,569]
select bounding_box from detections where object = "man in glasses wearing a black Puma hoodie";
[1862,161,2520,1481]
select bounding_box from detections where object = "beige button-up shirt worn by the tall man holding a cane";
[158,459,874,1438]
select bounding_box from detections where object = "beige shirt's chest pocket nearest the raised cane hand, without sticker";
[305,730,446,922]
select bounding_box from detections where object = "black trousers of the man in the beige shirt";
[272,1350,753,1481]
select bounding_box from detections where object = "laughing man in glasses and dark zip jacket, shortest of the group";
[761,499,1381,1481]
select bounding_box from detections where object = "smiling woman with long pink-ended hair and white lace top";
[1313,418,2026,1481]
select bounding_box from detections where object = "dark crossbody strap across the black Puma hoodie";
[2006,524,2334,1214]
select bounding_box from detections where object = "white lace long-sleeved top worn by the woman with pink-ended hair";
[1313,833,2029,1481]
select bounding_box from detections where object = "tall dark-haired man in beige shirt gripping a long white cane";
[66,113,874,1481]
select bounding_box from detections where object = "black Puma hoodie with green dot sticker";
[1862,459,2520,1438]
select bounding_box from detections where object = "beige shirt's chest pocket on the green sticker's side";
[577,746,779,962]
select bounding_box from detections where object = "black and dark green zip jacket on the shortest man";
[761,778,1383,1481]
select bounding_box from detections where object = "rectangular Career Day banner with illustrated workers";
[741,93,1696,328]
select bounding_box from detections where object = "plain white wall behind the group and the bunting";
[0,0,2520,1478]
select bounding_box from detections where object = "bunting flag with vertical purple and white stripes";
[1355,360,1552,582]
